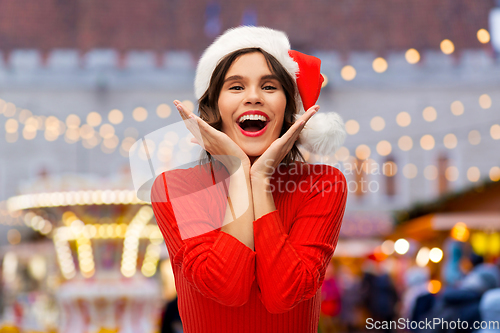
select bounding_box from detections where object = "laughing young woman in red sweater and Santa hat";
[151,27,347,333]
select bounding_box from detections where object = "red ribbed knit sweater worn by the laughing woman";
[151,163,348,333]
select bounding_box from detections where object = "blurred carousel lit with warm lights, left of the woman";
[4,173,172,333]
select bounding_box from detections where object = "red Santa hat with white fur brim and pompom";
[194,26,346,155]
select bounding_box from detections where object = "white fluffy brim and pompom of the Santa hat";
[194,26,346,155]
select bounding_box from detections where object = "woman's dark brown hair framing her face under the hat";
[198,48,305,166]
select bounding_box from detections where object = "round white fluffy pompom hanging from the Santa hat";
[297,112,346,156]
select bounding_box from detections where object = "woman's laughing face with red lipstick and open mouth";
[218,52,286,162]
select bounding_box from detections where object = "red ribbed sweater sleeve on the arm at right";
[254,169,348,313]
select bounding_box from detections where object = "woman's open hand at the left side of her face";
[174,100,250,174]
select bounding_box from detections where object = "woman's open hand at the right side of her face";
[250,105,319,182]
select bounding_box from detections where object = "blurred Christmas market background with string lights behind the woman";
[0,0,500,332]
